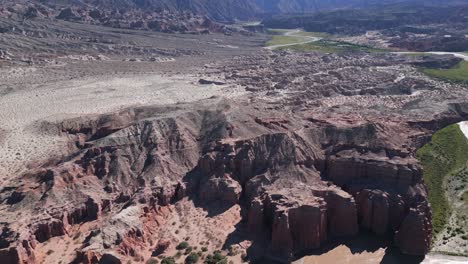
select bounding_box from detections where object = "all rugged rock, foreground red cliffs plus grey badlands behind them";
[0,48,468,263]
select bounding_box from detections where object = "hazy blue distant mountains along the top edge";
[0,0,468,21]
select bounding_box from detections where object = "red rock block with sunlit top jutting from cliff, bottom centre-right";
[248,185,358,259]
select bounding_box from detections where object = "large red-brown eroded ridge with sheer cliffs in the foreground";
[0,96,454,263]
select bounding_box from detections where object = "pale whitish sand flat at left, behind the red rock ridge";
[0,72,244,184]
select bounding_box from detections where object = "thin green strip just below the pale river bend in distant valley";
[284,39,386,53]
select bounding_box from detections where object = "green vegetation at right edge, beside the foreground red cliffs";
[417,124,468,235]
